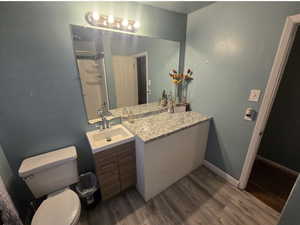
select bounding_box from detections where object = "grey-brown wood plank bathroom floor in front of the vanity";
[80,167,279,225]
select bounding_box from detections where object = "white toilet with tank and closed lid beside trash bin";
[19,146,81,225]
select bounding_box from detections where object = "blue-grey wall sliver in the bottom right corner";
[278,177,300,225]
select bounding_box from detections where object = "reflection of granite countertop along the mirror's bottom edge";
[109,102,167,118]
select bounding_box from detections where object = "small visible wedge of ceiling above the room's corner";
[140,1,214,14]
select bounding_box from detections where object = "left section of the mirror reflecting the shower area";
[72,26,108,120]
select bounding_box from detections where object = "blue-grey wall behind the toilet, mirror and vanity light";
[0,2,186,200]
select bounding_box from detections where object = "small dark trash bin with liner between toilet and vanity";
[75,172,98,205]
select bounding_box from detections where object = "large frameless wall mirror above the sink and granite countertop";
[71,25,180,121]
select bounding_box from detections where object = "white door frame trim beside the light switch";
[239,14,300,189]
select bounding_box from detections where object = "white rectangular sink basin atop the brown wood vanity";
[86,125,134,153]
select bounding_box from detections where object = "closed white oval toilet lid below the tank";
[31,189,81,225]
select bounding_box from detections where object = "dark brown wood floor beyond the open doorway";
[246,158,297,212]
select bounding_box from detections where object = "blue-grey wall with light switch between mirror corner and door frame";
[185,2,300,179]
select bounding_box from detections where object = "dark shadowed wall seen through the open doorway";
[259,26,300,172]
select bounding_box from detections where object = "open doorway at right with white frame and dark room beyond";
[239,15,300,212]
